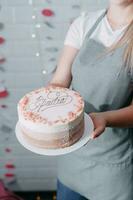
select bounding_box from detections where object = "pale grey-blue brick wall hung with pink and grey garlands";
[0,0,108,200]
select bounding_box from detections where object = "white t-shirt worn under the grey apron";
[64,9,127,49]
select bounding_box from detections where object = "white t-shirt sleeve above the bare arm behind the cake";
[64,15,83,49]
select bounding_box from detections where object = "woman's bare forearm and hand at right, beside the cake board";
[89,104,133,138]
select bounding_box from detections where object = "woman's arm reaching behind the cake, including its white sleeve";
[47,12,84,87]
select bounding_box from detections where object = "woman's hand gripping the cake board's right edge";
[89,113,107,139]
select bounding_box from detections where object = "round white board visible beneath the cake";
[15,113,94,156]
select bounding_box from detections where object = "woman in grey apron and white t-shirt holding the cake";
[50,0,133,200]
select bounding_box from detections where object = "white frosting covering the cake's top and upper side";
[18,87,84,134]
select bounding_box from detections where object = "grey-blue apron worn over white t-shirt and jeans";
[58,13,133,200]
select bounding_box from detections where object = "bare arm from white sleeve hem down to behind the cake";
[49,45,79,87]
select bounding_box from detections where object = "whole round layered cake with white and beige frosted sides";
[18,86,84,149]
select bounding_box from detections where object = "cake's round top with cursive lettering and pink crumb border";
[18,86,84,125]
